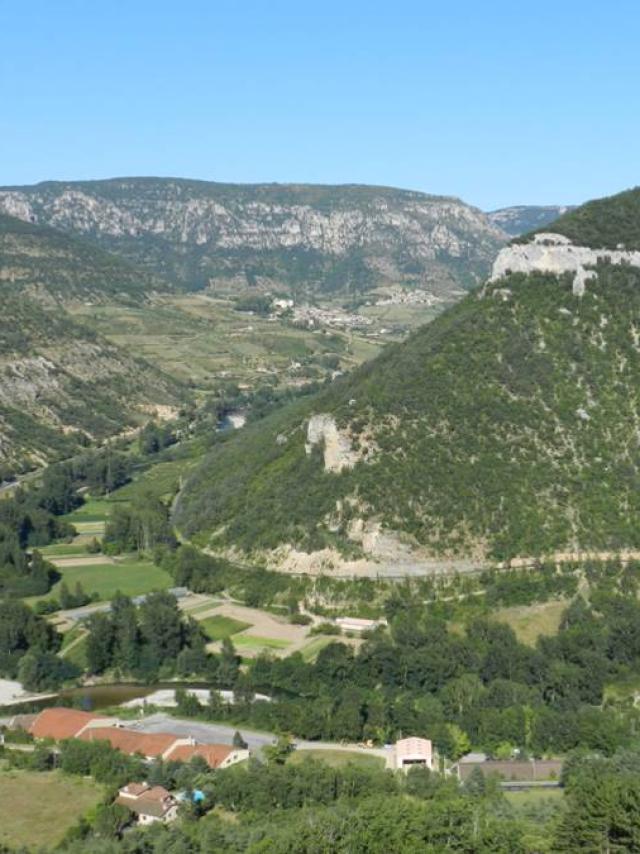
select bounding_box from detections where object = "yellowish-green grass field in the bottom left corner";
[0,770,103,850]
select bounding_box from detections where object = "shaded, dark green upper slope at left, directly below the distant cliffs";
[0,213,170,301]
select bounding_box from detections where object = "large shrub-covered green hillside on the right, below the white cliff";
[177,265,640,558]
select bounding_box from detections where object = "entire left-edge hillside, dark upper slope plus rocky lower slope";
[0,216,184,480]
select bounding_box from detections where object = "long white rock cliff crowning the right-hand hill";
[490,232,640,296]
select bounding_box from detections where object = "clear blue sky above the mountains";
[0,0,640,208]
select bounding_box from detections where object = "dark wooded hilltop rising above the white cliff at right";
[518,187,640,250]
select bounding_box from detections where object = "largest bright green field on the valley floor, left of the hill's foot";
[45,558,172,601]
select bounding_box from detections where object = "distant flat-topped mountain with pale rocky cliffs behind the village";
[0,178,506,299]
